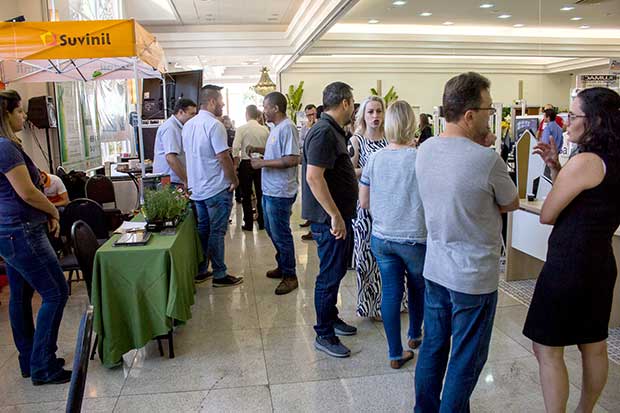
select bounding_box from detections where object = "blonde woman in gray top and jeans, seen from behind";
[359,101,426,369]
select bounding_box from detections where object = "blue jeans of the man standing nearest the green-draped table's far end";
[194,189,233,280]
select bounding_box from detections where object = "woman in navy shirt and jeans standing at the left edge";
[0,90,71,386]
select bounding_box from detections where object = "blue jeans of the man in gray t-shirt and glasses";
[415,280,497,413]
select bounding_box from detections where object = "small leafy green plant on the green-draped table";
[142,185,189,222]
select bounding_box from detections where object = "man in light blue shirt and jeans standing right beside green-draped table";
[182,85,243,287]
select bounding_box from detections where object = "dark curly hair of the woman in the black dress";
[577,87,620,162]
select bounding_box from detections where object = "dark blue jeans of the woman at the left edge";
[0,223,69,381]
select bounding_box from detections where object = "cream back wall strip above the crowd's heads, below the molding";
[281,72,572,113]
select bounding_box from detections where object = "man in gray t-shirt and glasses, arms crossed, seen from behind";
[415,72,519,412]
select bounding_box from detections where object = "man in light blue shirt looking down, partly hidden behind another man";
[153,99,196,185]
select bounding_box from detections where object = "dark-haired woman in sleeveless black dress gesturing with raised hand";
[523,88,620,412]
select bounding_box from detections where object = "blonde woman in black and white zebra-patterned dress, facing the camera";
[350,96,389,319]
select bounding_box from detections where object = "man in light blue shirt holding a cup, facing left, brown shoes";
[248,92,299,295]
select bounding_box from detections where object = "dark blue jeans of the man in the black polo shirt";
[310,220,353,338]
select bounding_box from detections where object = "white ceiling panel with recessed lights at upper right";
[339,0,620,29]
